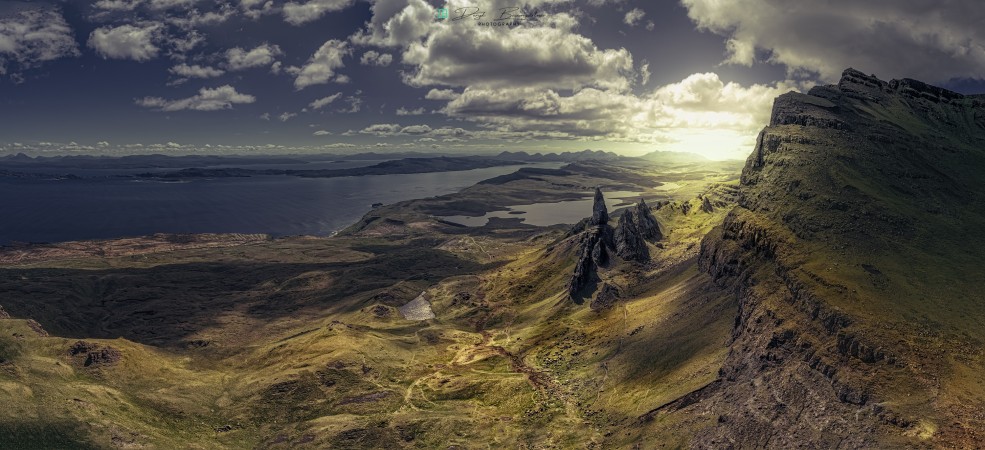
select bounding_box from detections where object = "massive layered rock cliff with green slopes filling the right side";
[692,69,985,448]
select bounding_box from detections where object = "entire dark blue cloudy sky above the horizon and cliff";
[0,0,985,159]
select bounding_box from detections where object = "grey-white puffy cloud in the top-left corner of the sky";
[0,9,79,75]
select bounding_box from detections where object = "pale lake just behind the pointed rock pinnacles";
[441,191,642,227]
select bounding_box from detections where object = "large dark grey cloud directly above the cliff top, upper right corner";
[681,0,985,82]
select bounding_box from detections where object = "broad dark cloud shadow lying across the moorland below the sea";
[0,245,486,347]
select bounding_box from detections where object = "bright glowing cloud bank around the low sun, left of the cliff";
[426,73,792,158]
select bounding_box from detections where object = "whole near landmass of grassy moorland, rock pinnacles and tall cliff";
[0,69,985,449]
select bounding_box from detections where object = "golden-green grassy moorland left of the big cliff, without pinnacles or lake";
[0,163,737,449]
